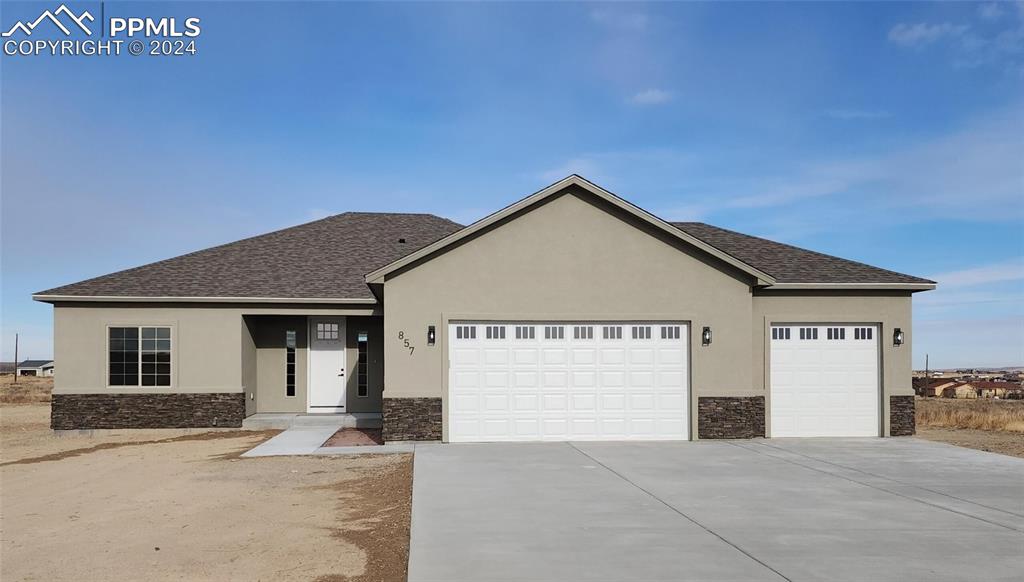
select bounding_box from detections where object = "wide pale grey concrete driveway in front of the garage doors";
[409,439,1024,582]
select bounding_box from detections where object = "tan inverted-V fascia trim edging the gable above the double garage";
[367,174,775,285]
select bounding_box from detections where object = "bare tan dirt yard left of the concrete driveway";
[0,403,412,582]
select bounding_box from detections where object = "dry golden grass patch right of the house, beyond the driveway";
[916,398,1024,432]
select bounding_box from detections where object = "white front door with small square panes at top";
[308,318,346,412]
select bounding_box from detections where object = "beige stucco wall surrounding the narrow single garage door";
[752,290,913,434]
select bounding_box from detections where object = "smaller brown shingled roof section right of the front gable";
[672,222,934,284]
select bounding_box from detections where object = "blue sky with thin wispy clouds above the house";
[0,1,1024,369]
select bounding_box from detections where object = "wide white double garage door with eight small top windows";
[447,322,689,443]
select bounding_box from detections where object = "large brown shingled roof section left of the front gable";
[34,212,462,303]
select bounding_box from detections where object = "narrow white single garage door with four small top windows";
[771,324,881,437]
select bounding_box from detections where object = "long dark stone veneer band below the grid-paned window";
[50,392,246,430]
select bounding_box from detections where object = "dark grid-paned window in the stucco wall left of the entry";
[108,327,171,386]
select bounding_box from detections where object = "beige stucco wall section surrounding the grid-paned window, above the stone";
[53,305,243,393]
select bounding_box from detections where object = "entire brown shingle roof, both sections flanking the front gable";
[38,212,932,299]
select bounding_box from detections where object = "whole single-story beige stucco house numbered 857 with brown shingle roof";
[34,175,935,442]
